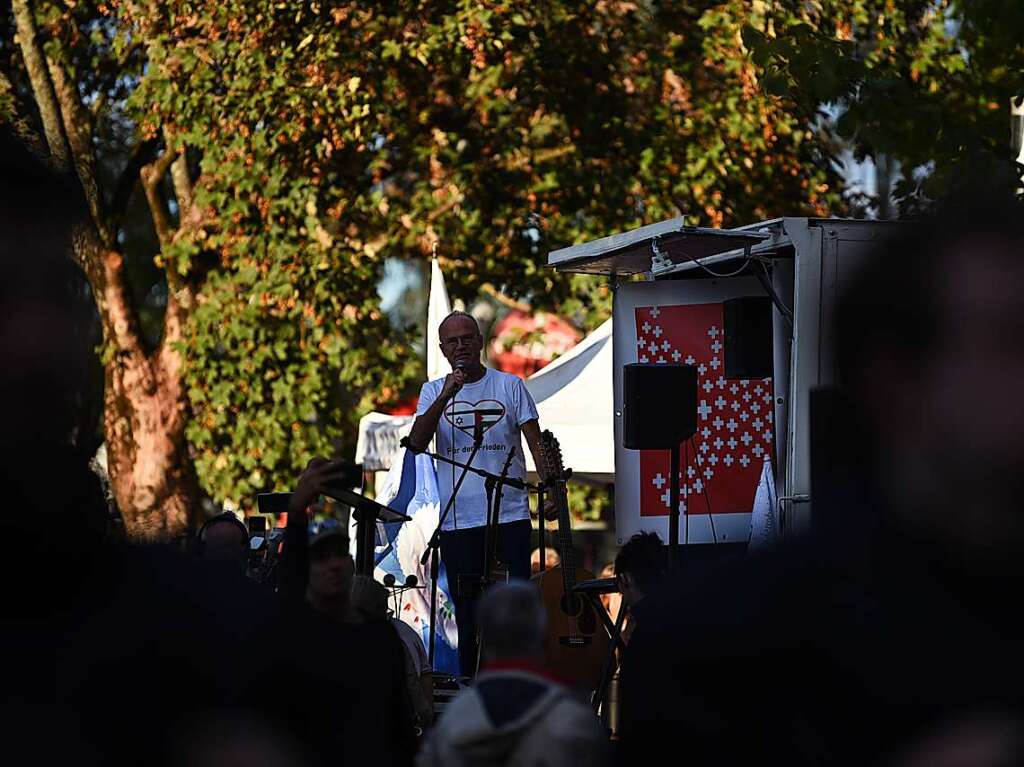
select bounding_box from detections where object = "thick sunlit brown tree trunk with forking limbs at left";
[13,0,199,540]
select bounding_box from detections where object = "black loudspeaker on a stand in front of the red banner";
[623,364,697,450]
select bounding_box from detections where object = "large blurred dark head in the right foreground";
[837,194,1024,570]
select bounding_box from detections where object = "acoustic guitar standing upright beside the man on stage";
[535,431,610,690]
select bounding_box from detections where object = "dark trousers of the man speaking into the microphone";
[441,519,530,677]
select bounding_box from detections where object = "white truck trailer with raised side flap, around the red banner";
[548,217,894,544]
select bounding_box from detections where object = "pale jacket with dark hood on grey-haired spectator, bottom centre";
[417,668,609,767]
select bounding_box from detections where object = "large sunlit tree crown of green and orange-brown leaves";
[8,0,844,514]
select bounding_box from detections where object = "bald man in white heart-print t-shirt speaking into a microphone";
[409,311,545,676]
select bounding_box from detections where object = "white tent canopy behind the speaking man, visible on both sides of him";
[355,319,615,483]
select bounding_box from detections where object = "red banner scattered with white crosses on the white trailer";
[636,303,774,517]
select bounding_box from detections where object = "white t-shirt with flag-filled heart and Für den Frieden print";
[416,368,537,530]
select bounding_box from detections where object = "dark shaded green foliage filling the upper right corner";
[743,0,1024,212]
